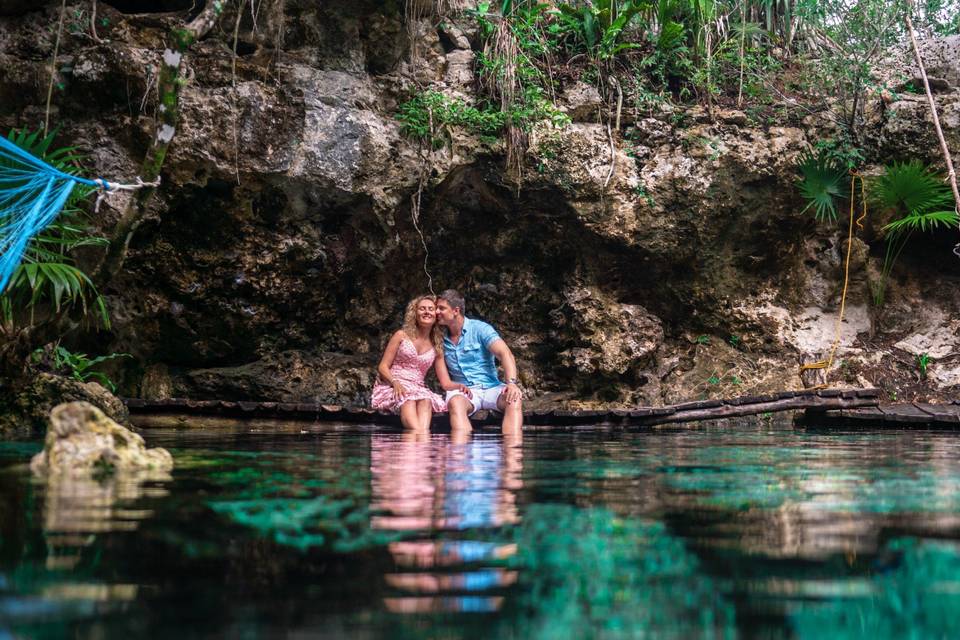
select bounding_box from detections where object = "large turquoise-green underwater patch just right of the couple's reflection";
[498,504,736,638]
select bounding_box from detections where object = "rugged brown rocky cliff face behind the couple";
[0,0,960,406]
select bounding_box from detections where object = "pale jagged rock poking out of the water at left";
[30,401,173,475]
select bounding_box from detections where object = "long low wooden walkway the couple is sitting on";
[125,389,880,428]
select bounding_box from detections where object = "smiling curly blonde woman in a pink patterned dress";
[370,295,458,431]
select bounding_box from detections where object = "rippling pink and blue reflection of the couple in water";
[370,431,523,613]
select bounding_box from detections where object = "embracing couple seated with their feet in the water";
[371,289,523,435]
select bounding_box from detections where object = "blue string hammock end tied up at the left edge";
[0,137,110,292]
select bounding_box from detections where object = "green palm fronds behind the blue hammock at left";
[0,129,110,328]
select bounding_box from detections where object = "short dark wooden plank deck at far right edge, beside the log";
[803,400,960,429]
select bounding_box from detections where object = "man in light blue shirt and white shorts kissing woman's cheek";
[437,289,523,435]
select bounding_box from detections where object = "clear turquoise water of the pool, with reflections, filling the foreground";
[0,423,960,639]
